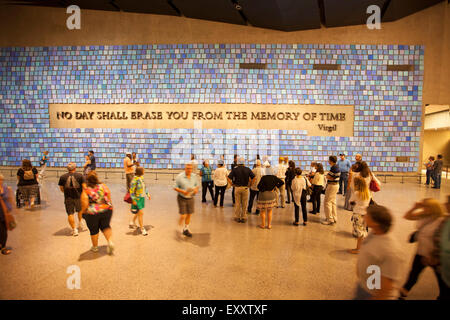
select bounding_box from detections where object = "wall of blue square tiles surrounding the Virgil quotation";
[0,44,424,172]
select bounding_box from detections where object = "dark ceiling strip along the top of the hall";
[6,0,445,31]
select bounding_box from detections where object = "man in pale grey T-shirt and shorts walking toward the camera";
[174,163,200,237]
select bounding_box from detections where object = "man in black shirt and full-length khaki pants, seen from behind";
[228,157,255,223]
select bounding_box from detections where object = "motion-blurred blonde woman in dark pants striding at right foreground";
[400,198,449,300]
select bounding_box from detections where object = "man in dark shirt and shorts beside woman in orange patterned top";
[58,162,85,237]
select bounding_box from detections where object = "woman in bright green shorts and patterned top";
[130,167,150,236]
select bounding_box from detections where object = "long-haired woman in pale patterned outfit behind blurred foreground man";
[349,176,371,254]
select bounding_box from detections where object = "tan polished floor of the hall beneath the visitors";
[0,178,450,300]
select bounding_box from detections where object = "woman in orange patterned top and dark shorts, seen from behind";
[81,171,114,255]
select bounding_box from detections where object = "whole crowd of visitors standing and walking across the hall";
[0,151,450,299]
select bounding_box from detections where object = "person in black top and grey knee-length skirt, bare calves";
[257,161,284,229]
